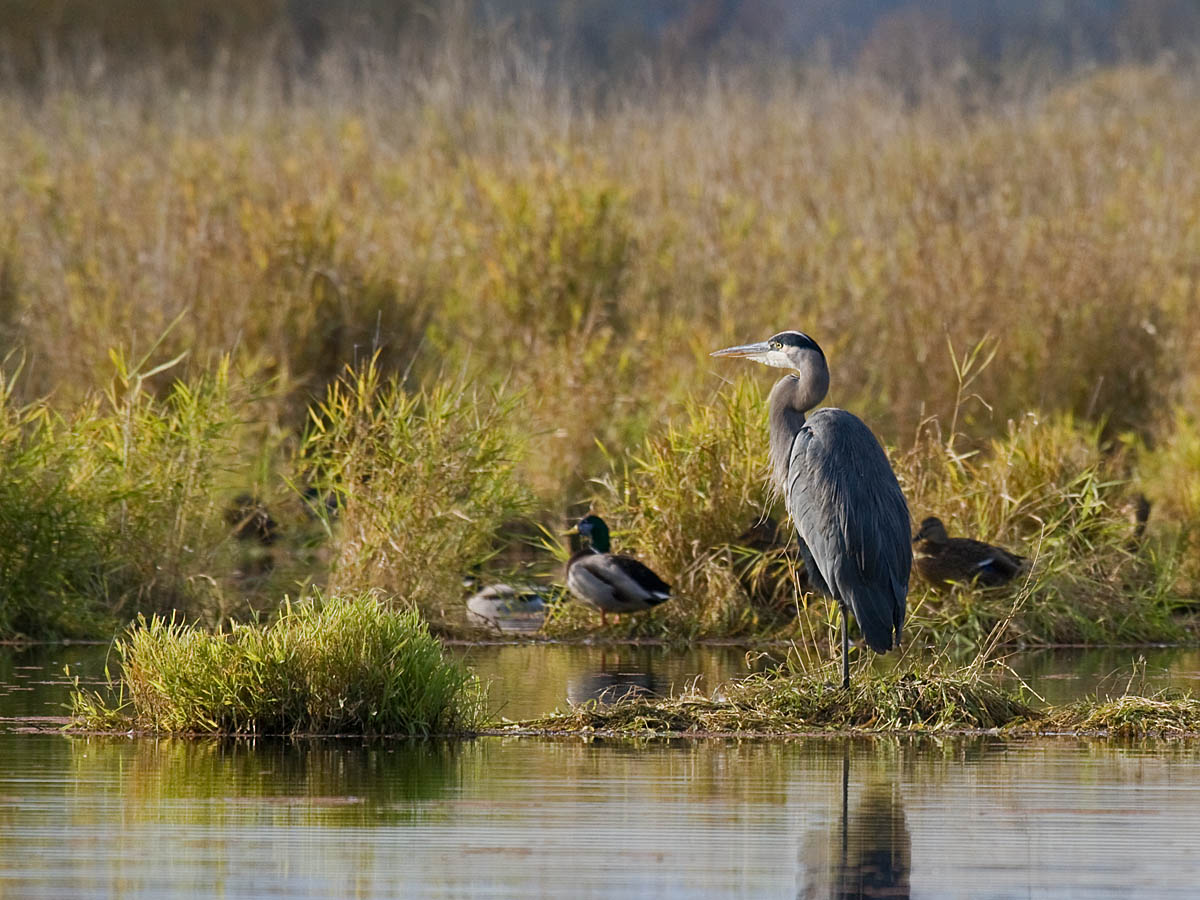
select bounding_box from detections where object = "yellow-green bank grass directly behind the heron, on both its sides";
[546,400,1193,653]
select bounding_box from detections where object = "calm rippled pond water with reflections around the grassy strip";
[0,647,1200,899]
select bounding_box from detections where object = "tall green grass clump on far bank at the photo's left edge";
[0,353,253,640]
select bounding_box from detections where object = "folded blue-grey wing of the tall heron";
[786,409,912,653]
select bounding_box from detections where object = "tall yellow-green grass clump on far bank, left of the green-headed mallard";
[300,362,530,620]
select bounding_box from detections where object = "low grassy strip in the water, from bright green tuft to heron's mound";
[71,628,1200,738]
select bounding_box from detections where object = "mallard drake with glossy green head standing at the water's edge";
[566,516,671,625]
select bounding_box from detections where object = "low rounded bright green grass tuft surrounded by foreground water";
[72,593,485,734]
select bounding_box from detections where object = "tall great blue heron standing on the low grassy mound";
[713,331,912,688]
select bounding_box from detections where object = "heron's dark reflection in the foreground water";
[797,757,912,900]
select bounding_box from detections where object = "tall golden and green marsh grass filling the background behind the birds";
[0,0,1200,642]
